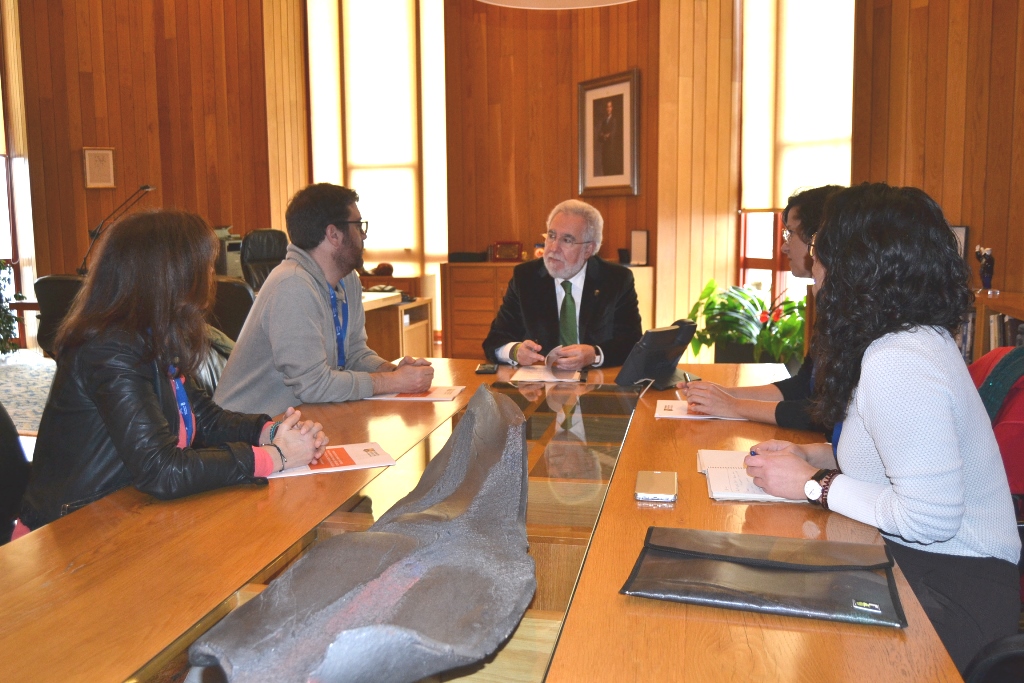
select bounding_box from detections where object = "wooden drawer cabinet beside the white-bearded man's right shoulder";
[441,263,517,359]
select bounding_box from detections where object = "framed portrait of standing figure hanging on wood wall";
[579,69,640,197]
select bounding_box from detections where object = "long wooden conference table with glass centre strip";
[0,359,959,682]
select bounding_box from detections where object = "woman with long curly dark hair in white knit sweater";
[746,183,1021,672]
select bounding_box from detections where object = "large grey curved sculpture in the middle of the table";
[188,386,537,683]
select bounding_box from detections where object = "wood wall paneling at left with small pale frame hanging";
[19,0,288,274]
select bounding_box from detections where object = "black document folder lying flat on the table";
[621,526,906,628]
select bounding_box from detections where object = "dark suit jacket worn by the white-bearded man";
[483,256,642,366]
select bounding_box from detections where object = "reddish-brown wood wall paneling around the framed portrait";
[445,0,657,270]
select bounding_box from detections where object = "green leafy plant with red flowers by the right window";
[689,280,805,364]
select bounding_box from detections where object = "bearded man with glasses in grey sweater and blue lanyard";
[214,182,434,415]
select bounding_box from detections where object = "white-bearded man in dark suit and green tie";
[483,200,641,370]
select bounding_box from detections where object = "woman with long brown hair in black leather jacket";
[14,211,327,538]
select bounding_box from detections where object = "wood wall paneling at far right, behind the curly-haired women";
[852,0,1024,291]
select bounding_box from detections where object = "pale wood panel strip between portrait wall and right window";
[655,0,739,325]
